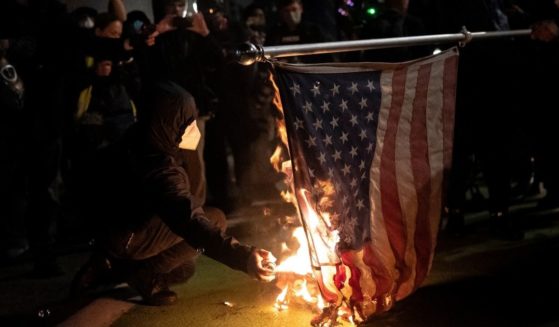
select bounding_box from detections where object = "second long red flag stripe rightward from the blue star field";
[410,64,432,289]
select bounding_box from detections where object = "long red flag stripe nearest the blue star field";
[380,68,407,290]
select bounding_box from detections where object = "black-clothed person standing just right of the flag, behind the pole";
[424,0,525,240]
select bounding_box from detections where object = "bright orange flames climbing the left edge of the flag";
[270,74,353,326]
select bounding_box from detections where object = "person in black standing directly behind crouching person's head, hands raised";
[135,0,231,208]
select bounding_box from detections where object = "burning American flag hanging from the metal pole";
[274,48,458,319]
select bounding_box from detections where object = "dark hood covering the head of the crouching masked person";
[140,81,197,154]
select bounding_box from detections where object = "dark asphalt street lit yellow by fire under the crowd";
[0,200,559,327]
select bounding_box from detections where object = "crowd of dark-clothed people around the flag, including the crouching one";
[0,0,559,305]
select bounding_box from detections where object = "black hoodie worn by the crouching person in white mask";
[88,82,252,272]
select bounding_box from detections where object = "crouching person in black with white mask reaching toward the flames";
[71,82,275,305]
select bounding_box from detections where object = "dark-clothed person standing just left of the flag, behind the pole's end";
[206,5,279,210]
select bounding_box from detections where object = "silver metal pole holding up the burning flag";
[233,28,531,65]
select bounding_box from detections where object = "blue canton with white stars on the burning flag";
[281,72,380,249]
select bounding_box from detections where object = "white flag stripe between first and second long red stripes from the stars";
[395,65,419,300]
